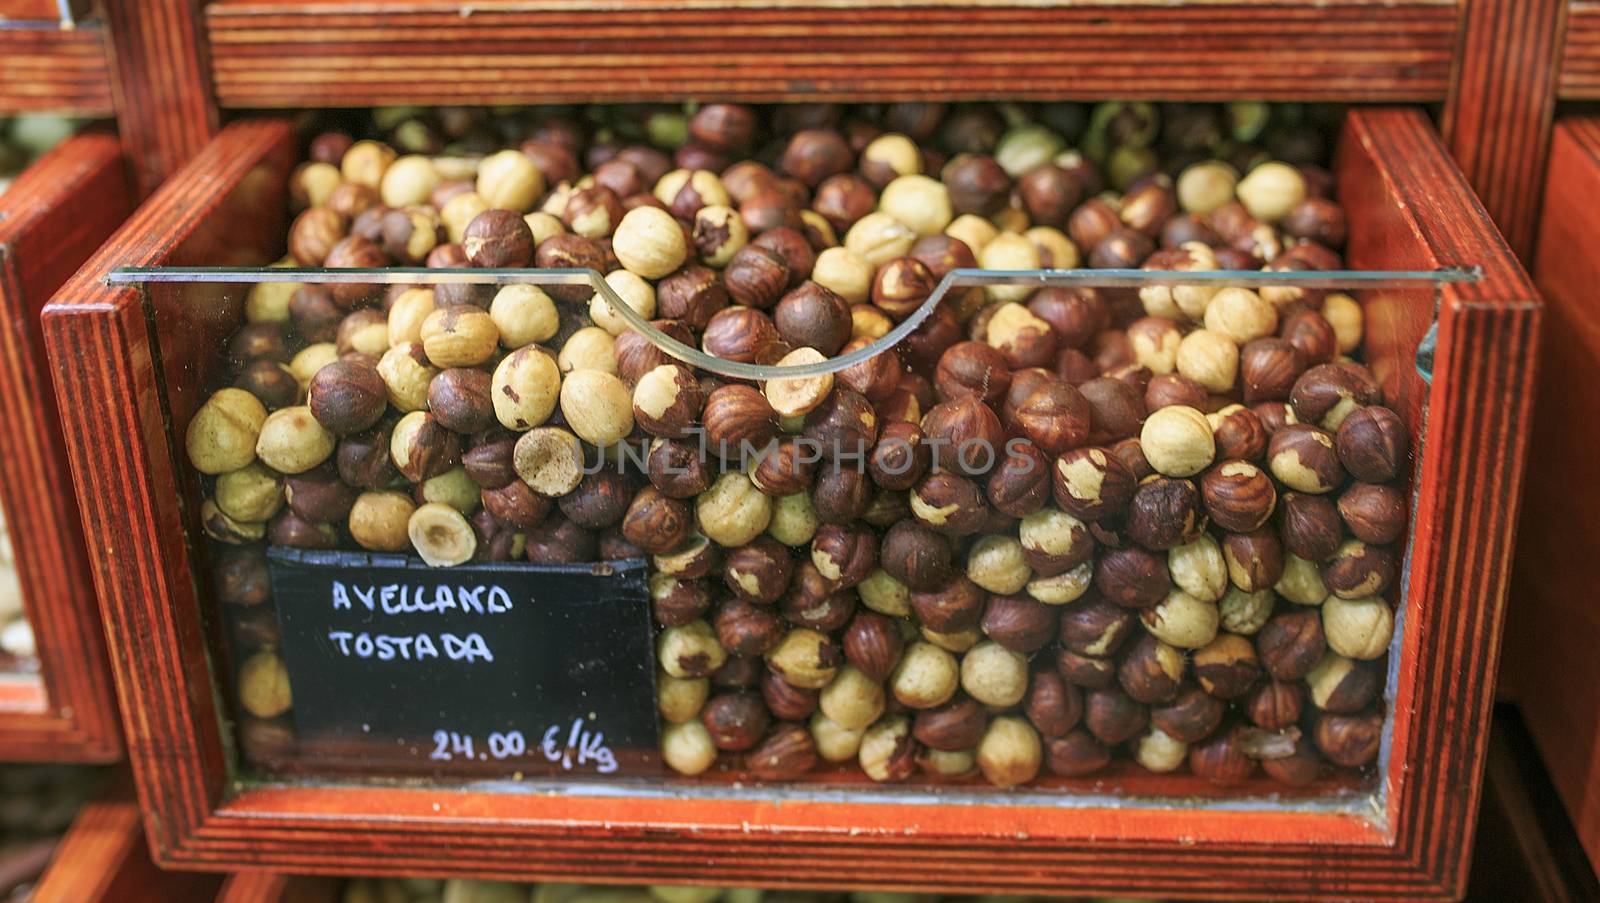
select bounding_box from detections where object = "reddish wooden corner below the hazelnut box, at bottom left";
[29,788,221,903]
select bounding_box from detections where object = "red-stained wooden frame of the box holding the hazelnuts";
[45,109,1541,898]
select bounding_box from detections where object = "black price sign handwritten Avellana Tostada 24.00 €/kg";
[267,548,658,775]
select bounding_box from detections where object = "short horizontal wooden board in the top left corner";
[0,22,114,118]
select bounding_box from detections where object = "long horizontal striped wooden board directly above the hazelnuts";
[205,0,1459,109]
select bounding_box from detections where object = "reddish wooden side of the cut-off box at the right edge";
[1506,118,1600,883]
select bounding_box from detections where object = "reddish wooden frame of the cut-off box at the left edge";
[0,131,131,762]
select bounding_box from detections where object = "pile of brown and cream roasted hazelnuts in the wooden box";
[187,104,1408,786]
